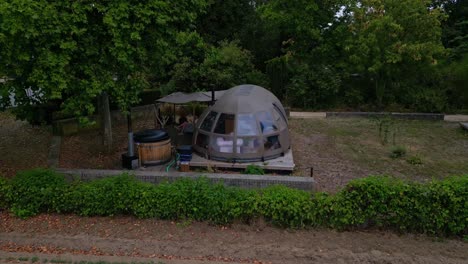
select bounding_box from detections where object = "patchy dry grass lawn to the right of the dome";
[290,118,468,184]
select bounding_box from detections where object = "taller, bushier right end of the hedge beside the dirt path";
[331,176,468,235]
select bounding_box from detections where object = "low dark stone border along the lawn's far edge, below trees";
[326,112,445,121]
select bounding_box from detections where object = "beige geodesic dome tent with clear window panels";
[193,85,290,162]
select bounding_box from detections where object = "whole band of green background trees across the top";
[0,0,468,122]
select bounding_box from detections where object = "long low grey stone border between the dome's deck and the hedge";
[57,169,315,191]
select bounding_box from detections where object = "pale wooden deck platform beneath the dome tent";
[190,149,295,171]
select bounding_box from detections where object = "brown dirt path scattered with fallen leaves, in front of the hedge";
[0,213,468,263]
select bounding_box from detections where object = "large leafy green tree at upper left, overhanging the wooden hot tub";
[0,0,206,124]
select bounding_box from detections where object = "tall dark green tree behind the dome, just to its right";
[258,0,341,105]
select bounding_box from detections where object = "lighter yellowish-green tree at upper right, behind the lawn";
[344,0,444,106]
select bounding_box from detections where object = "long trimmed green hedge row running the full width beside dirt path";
[0,169,468,236]
